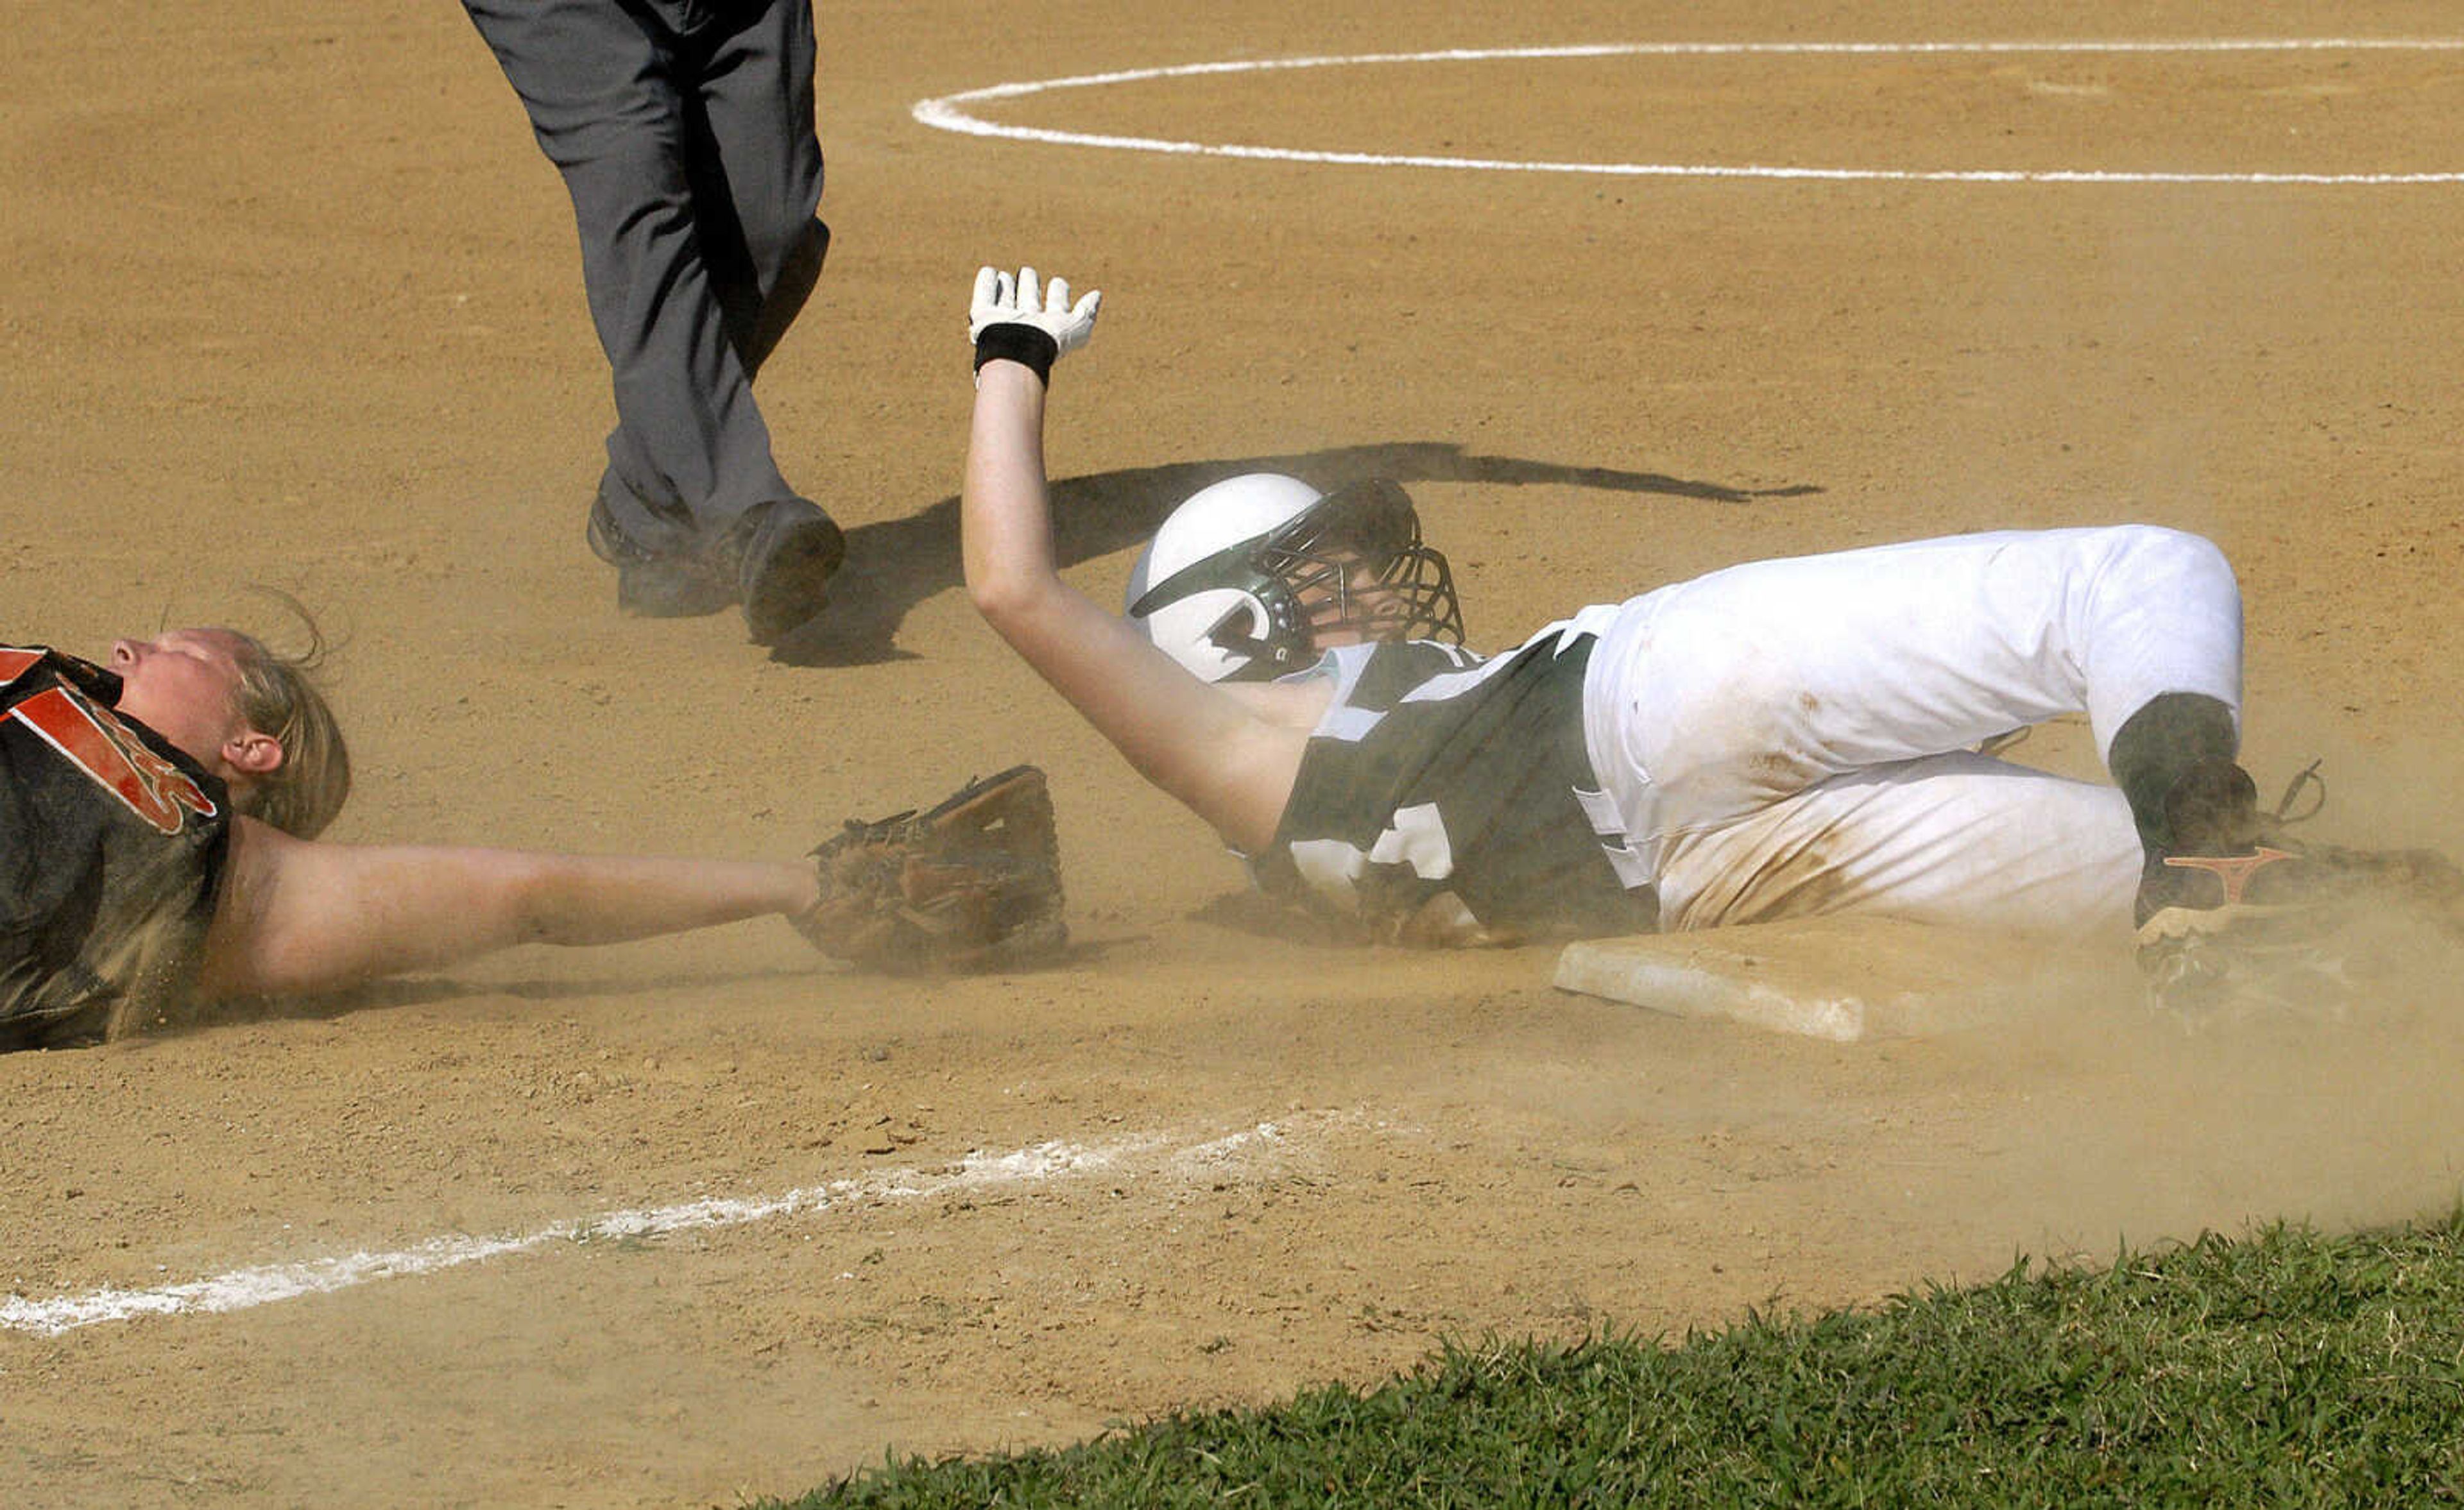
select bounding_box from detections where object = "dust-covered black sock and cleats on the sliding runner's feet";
[2136,761,2464,1010]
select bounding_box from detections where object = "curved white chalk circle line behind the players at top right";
[909,37,2464,185]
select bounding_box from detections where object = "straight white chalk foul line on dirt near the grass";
[0,1121,1291,1337]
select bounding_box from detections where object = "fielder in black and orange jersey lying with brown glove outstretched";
[0,628,1065,1049]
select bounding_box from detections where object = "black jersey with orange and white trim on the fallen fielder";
[0,645,232,1049]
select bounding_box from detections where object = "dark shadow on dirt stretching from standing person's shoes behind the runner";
[771,441,1821,665]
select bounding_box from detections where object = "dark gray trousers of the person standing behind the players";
[463,0,828,554]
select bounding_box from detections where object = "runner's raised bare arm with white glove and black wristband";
[961,269,1318,853]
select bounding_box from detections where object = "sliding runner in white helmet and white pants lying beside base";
[961,269,2464,997]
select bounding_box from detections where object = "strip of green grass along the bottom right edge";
[774,1212,2464,1510]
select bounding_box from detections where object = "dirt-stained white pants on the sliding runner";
[1584,525,2242,936]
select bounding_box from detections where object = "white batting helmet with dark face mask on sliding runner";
[1129,473,1464,683]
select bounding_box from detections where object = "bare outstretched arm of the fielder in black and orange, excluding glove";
[200,818,818,995]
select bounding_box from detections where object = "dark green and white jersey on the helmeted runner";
[1252,624,1658,944]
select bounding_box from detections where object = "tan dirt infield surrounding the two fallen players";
[0,0,2464,1505]
